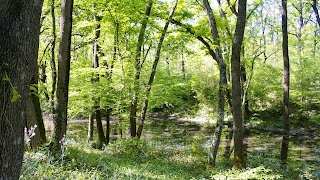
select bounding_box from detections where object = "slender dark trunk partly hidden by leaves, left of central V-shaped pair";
[92,3,106,146]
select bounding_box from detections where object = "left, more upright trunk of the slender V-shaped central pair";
[130,0,153,137]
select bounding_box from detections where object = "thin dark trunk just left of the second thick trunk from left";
[50,0,57,116]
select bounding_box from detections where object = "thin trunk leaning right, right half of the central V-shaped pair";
[137,0,178,138]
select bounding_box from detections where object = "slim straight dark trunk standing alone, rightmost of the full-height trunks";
[281,0,290,169]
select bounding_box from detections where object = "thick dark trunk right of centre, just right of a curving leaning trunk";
[231,0,247,169]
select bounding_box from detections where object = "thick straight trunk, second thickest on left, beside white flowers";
[53,0,73,151]
